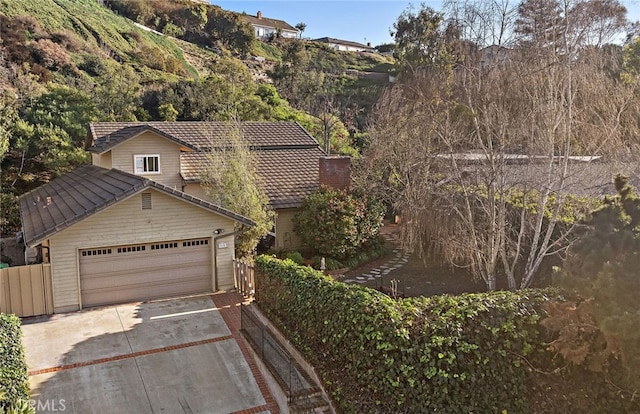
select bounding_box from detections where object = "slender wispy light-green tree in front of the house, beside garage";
[202,122,274,258]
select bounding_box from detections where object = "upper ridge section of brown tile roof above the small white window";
[89,121,318,151]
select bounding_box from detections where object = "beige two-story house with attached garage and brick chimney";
[20,122,349,312]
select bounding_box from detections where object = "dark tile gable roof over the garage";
[19,165,255,246]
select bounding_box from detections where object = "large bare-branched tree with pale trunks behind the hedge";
[359,0,633,289]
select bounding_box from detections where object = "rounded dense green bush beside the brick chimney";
[293,187,384,260]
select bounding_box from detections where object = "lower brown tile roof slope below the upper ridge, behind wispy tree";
[181,147,324,209]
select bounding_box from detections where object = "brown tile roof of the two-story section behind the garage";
[90,121,324,208]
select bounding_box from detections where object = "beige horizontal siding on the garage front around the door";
[50,189,234,312]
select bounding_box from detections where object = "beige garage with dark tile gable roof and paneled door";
[20,166,254,312]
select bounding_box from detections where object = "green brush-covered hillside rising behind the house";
[0,0,391,234]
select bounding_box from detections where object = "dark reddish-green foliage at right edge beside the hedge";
[547,176,640,394]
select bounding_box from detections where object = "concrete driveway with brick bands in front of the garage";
[22,295,271,414]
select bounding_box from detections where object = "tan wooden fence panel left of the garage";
[0,263,53,317]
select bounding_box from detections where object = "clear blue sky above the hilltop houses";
[210,0,640,46]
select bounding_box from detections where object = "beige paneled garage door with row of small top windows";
[80,239,213,307]
